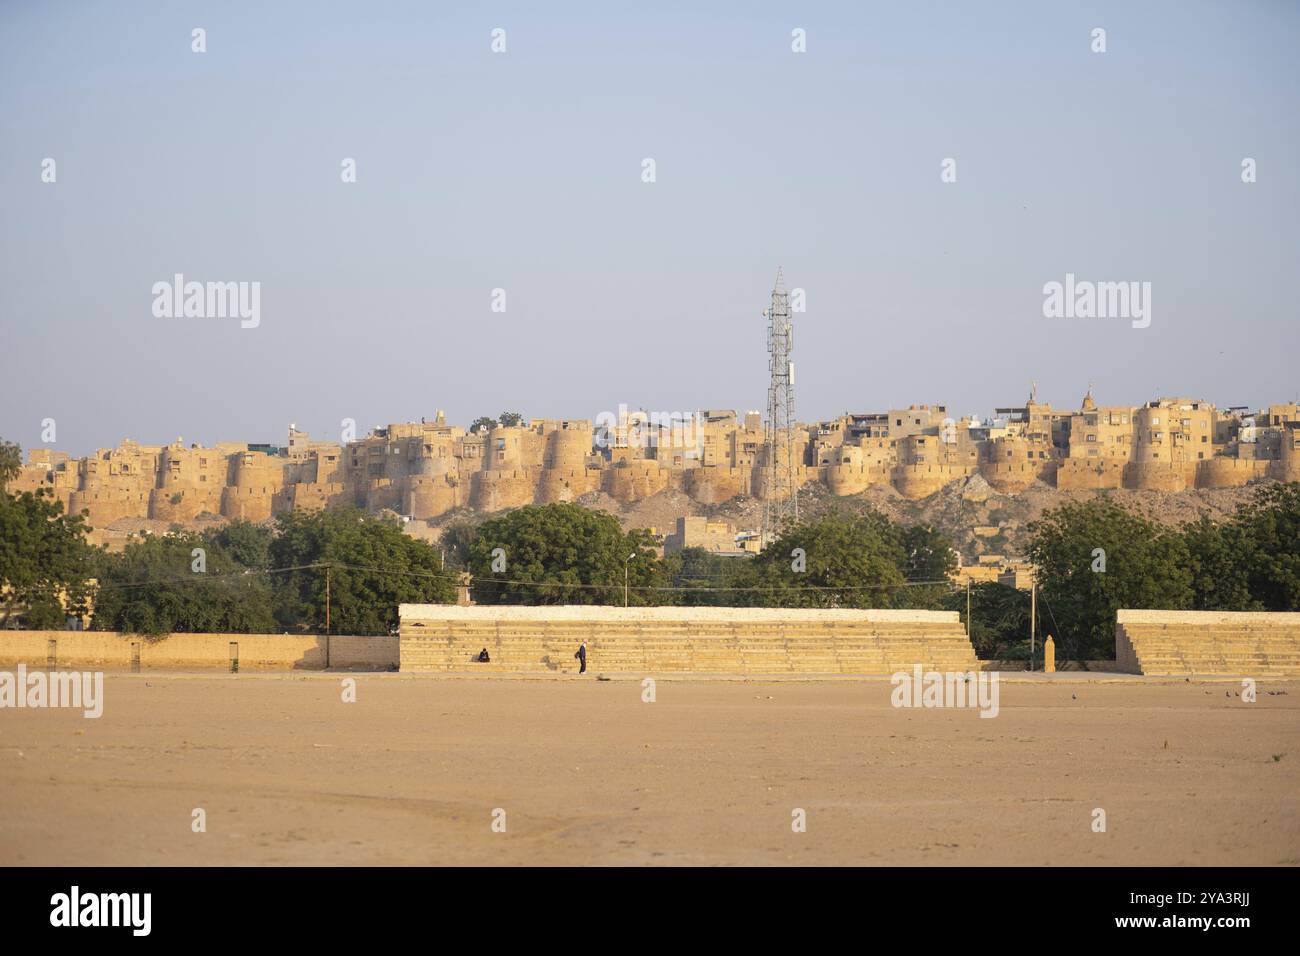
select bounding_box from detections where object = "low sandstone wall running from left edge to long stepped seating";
[0,631,398,671]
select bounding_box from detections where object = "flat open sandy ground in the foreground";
[0,674,1300,865]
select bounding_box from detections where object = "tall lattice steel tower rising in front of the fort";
[762,269,800,548]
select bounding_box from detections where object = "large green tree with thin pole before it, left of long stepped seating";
[270,509,456,635]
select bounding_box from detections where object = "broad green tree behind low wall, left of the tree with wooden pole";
[94,532,277,636]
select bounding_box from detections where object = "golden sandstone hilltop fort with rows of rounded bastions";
[10,390,1300,541]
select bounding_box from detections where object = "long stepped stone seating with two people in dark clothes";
[400,609,979,675]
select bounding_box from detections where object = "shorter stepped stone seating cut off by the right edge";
[1115,611,1300,676]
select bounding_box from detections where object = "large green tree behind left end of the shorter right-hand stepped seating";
[1027,498,1193,659]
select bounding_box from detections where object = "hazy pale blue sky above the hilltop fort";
[0,0,1300,454]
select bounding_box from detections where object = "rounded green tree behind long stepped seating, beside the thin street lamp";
[469,503,664,605]
